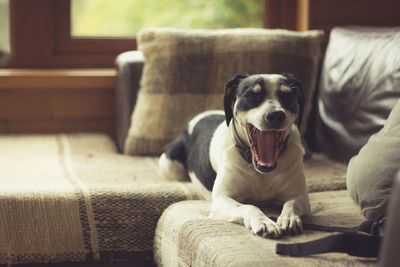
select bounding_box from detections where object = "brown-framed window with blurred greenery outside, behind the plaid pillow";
[7,0,282,68]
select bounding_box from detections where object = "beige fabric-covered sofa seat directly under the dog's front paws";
[154,191,376,266]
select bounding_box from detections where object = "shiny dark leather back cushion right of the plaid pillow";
[316,27,400,162]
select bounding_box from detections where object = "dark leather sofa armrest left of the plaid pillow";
[115,51,144,151]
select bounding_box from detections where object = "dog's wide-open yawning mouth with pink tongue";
[246,123,285,173]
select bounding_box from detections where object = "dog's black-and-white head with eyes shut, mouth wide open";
[224,74,303,173]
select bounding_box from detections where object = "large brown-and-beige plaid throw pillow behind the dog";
[124,28,322,155]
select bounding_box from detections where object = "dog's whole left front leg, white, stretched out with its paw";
[210,197,282,238]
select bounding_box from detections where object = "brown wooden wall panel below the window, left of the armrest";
[0,69,115,134]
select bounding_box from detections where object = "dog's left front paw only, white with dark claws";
[244,211,282,238]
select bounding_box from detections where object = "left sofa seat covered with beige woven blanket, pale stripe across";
[0,134,197,264]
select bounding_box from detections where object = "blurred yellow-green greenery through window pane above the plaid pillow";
[72,0,264,37]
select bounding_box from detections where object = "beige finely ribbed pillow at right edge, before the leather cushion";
[347,100,400,220]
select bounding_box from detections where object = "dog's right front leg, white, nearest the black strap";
[276,193,310,233]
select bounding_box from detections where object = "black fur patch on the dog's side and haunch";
[164,114,225,191]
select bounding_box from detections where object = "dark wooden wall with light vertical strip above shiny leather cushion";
[265,0,400,44]
